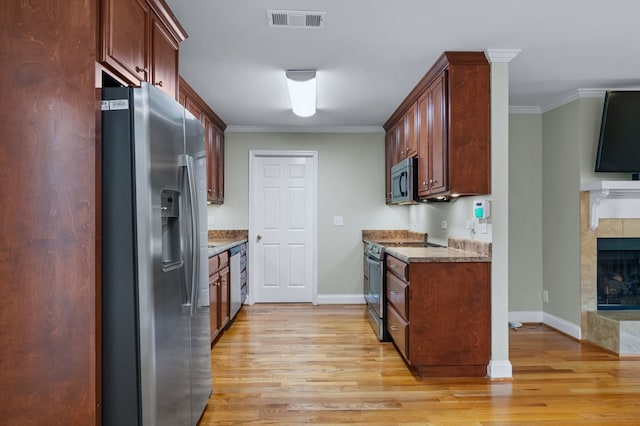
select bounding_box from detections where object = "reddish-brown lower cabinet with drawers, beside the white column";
[386,255,491,376]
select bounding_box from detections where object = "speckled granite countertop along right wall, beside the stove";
[362,230,491,262]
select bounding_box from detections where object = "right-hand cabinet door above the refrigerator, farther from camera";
[151,19,178,99]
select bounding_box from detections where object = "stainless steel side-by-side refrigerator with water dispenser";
[100,84,211,426]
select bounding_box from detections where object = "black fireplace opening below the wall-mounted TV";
[597,238,640,310]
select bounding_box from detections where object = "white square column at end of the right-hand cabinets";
[485,49,520,379]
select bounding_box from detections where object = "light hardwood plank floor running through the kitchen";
[200,304,640,426]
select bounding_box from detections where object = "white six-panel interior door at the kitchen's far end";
[249,151,317,304]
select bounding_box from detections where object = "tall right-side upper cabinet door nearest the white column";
[427,71,448,194]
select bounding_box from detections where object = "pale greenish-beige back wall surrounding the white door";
[208,132,408,296]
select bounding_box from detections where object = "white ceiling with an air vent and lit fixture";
[167,0,640,131]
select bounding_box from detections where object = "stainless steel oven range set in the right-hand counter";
[364,242,389,341]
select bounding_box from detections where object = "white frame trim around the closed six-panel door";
[247,150,318,305]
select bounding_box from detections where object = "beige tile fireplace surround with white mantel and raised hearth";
[580,182,640,355]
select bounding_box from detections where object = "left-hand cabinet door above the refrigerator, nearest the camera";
[101,0,150,85]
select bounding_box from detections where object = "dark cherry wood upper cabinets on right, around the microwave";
[384,52,491,200]
